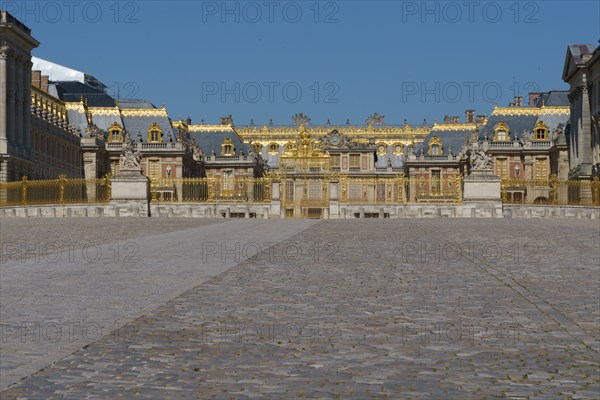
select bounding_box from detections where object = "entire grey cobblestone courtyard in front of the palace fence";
[0,218,600,400]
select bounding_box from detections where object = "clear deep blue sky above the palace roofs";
[0,1,600,124]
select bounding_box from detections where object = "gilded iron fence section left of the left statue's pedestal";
[0,175,111,207]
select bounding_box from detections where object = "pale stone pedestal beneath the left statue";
[110,170,150,217]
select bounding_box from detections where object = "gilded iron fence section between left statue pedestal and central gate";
[150,177,271,203]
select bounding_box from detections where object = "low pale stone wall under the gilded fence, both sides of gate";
[0,201,600,219]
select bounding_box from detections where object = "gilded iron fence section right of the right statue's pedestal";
[501,175,600,206]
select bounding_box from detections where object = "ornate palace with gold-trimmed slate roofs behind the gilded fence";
[0,11,600,209]
